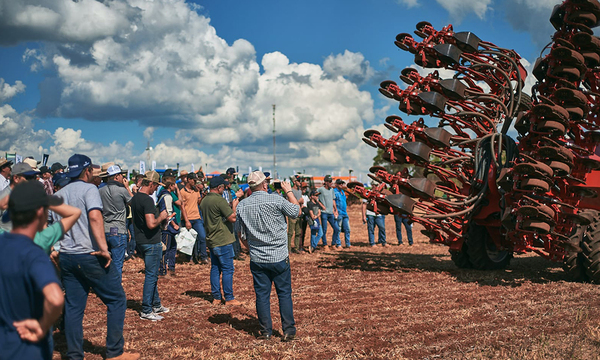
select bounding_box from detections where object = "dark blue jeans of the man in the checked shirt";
[250,258,296,335]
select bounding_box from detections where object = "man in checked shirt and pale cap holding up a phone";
[236,171,300,342]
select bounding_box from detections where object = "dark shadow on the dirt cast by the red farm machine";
[318,252,571,286]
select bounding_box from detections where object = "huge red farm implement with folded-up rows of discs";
[349,0,600,282]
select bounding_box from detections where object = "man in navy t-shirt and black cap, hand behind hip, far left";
[0,180,64,360]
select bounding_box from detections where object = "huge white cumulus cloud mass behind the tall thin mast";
[0,0,375,176]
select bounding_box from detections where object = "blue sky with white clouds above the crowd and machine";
[0,0,559,175]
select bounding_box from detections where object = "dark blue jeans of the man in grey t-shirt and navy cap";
[60,253,127,359]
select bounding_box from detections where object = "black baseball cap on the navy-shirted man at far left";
[8,180,63,212]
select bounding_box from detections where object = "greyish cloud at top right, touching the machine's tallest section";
[504,0,562,48]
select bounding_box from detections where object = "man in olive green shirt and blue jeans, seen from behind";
[200,176,242,305]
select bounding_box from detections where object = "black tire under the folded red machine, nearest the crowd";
[465,221,512,270]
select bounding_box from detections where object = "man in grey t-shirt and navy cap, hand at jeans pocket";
[53,154,140,360]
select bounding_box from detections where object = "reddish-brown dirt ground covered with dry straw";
[54,207,600,360]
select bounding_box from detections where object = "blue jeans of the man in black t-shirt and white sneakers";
[138,243,162,314]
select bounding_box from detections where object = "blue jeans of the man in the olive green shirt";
[210,244,235,301]
